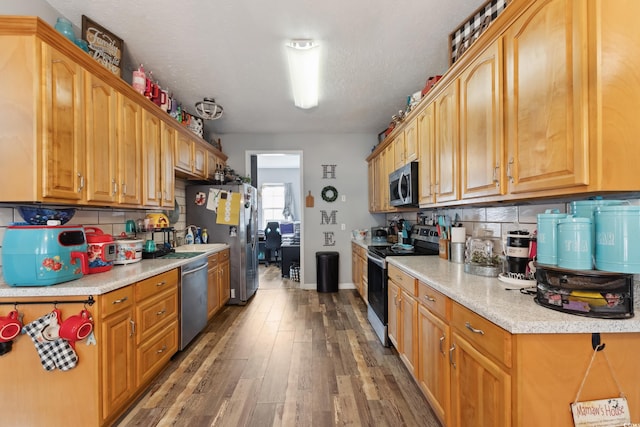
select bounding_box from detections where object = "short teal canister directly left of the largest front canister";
[557,216,593,270]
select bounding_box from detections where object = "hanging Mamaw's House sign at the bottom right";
[571,397,631,427]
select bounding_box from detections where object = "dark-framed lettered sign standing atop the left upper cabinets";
[82,15,123,77]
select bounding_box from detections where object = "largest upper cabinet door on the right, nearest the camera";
[504,0,589,193]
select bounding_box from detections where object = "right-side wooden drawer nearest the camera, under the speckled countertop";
[451,303,511,368]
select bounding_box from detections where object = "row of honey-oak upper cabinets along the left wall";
[0,16,227,208]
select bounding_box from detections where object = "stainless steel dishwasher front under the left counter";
[180,257,208,350]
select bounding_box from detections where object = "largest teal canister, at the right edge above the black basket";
[595,205,640,274]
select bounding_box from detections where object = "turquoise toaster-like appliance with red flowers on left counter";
[2,225,89,286]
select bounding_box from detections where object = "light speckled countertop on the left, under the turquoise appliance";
[0,244,229,298]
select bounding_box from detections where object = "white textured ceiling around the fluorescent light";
[47,0,485,134]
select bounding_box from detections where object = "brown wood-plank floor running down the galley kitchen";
[118,266,439,427]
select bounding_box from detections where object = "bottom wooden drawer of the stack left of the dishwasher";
[136,320,178,387]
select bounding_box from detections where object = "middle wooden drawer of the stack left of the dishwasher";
[136,289,178,344]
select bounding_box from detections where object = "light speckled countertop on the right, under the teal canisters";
[386,256,640,334]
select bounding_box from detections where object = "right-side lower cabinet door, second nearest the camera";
[418,305,451,425]
